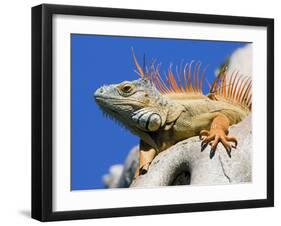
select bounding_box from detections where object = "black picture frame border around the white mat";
[32,4,274,221]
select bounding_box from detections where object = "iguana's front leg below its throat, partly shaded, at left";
[135,140,156,178]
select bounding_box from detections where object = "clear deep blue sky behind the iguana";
[71,34,246,190]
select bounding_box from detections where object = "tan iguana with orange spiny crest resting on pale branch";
[94,50,252,177]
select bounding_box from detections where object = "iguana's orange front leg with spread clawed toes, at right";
[199,114,238,158]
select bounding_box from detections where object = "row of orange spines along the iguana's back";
[132,50,252,110]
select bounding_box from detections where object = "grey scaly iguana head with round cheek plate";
[94,78,168,135]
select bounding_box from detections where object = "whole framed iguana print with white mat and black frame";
[32,4,274,221]
